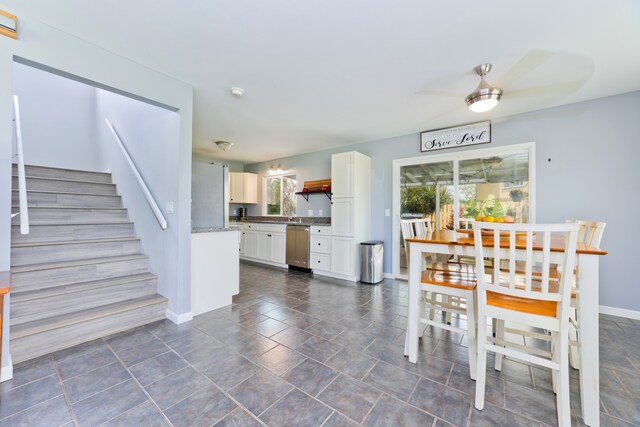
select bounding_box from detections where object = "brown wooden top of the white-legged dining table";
[407,230,607,255]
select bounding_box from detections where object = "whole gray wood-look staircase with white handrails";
[11,165,167,363]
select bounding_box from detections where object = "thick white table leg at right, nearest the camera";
[578,255,600,427]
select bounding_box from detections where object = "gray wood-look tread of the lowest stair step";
[11,294,167,340]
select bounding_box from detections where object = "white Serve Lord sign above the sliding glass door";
[420,121,491,152]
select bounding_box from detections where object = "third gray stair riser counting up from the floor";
[11,258,149,291]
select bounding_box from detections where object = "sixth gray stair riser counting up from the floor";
[11,206,129,225]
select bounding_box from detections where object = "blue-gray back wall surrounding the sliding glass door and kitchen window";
[245,92,640,310]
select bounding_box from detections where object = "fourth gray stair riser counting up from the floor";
[11,240,140,267]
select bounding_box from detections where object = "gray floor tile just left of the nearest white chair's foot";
[409,378,471,425]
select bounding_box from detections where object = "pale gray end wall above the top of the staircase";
[13,62,99,171]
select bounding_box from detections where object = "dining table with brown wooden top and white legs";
[406,230,607,427]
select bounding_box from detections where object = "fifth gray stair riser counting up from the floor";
[11,224,135,244]
